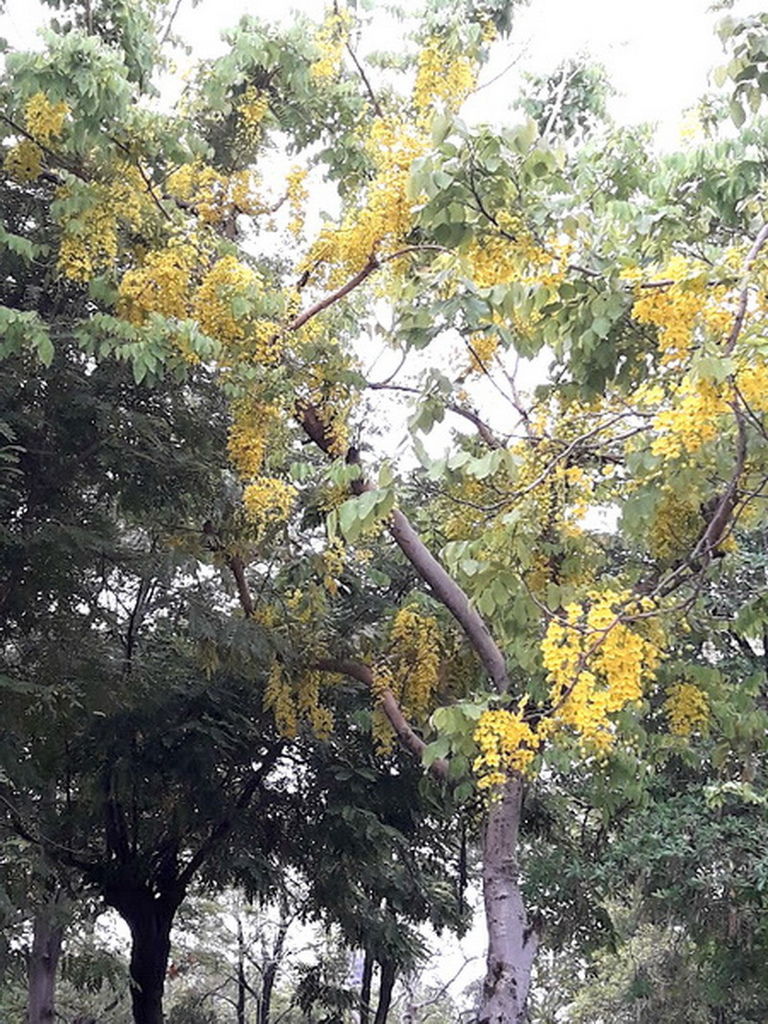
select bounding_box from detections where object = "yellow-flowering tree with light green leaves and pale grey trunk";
[3,2,768,1024]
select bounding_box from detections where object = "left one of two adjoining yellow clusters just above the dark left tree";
[118,242,198,324]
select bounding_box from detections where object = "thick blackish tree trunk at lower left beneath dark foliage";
[115,889,180,1024]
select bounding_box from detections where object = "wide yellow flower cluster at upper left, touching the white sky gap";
[166,160,266,224]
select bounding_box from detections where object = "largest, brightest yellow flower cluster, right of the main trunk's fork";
[540,591,662,752]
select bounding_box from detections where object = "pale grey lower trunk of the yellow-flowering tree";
[478,776,539,1024]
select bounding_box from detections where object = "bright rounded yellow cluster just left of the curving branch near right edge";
[651,377,729,459]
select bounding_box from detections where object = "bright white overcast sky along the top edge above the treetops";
[0,0,762,134]
